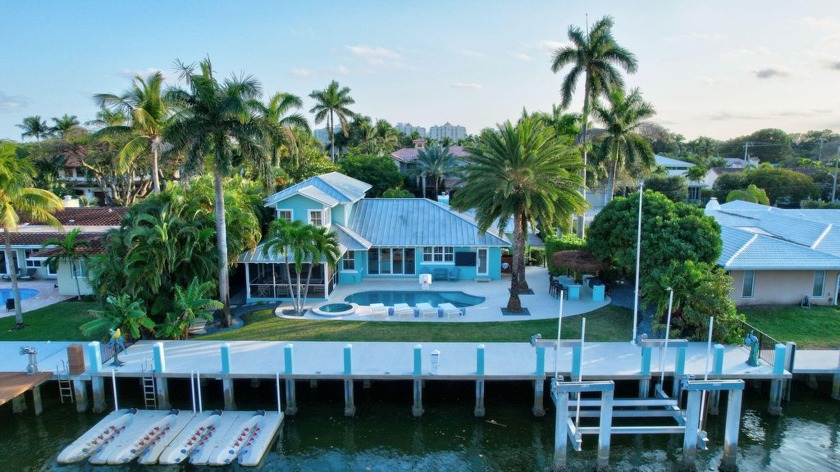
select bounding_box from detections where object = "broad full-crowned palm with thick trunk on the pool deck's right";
[451,118,586,312]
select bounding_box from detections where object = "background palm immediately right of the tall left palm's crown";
[257,93,311,187]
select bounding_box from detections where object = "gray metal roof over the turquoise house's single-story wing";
[347,198,510,247]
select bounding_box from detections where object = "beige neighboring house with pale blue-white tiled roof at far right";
[706,198,840,305]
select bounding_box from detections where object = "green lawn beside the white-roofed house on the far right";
[739,306,840,349]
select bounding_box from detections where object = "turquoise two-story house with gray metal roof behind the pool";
[239,172,510,301]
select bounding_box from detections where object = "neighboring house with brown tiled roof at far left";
[0,207,125,295]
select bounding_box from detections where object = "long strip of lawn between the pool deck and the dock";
[203,306,633,342]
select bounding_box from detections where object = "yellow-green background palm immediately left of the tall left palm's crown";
[93,72,170,193]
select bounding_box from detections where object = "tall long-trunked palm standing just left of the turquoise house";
[167,58,263,325]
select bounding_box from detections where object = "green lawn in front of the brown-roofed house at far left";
[0,302,101,341]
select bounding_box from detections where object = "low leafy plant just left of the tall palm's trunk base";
[155,279,222,339]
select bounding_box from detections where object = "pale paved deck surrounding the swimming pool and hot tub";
[288,266,610,323]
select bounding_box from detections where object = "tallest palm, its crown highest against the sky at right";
[551,16,638,236]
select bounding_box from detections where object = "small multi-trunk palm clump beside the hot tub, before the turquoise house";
[263,220,340,314]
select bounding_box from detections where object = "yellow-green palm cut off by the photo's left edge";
[0,143,62,329]
